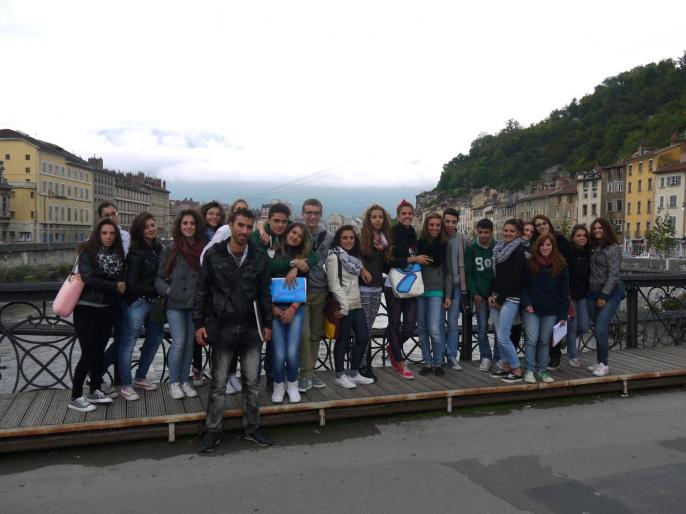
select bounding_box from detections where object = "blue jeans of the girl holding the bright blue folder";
[265,307,305,384]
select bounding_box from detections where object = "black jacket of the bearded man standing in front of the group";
[193,240,273,330]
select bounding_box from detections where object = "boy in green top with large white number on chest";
[464,218,500,371]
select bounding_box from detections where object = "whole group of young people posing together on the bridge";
[63,194,623,452]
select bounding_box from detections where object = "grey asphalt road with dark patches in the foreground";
[0,388,686,514]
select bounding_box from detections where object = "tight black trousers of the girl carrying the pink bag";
[71,303,119,399]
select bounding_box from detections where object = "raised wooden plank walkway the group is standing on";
[0,346,686,453]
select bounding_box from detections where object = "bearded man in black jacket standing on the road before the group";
[193,209,272,452]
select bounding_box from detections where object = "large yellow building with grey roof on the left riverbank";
[0,129,93,242]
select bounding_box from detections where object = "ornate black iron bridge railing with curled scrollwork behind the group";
[0,273,686,392]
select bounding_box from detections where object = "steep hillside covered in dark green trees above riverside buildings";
[437,53,686,193]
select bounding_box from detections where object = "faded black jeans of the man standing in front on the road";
[205,325,262,434]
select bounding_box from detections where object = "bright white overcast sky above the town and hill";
[0,0,686,194]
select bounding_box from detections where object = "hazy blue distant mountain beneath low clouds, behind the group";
[167,182,424,217]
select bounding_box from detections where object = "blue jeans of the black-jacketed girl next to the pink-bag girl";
[118,298,164,386]
